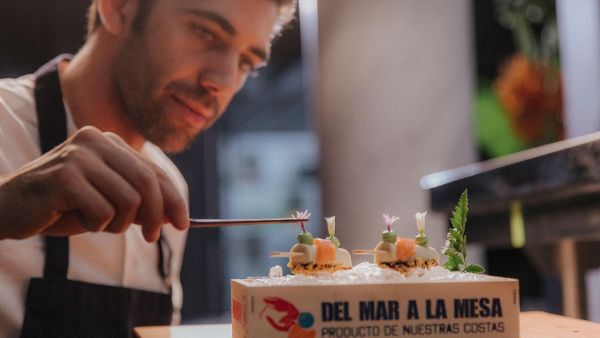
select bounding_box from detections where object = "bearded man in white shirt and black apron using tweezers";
[0,0,295,337]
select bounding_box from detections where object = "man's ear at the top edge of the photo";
[97,0,144,35]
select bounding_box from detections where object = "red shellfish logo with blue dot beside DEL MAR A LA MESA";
[259,297,317,338]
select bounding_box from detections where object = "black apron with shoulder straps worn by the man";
[21,58,173,338]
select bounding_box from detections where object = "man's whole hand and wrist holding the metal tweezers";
[0,127,189,242]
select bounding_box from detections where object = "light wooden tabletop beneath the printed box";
[135,312,600,338]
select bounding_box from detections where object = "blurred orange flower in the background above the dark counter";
[494,54,563,144]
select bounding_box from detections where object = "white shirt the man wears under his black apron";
[0,75,188,338]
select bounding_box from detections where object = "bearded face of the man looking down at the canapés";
[111,0,278,152]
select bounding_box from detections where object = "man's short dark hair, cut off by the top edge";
[87,0,298,38]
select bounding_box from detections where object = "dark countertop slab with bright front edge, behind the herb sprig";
[421,133,600,213]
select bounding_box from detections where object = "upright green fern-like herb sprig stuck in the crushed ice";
[442,190,485,273]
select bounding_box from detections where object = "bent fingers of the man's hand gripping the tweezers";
[72,130,189,242]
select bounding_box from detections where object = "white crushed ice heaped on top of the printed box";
[252,262,495,286]
